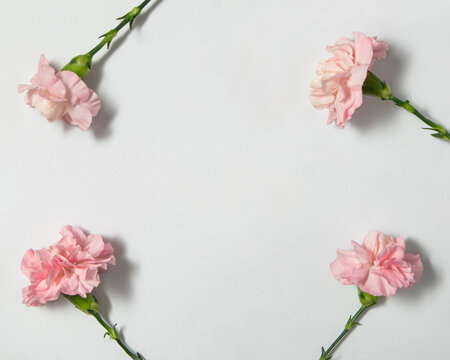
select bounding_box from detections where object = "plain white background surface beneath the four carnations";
[0,0,450,360]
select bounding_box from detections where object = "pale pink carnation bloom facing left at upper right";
[309,32,388,128]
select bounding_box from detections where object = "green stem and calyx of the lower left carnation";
[63,294,144,360]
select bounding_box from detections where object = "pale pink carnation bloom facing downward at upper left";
[17,55,100,130]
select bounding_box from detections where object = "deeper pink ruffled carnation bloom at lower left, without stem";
[21,226,115,306]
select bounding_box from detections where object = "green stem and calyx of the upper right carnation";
[362,71,450,141]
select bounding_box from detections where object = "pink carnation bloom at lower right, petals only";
[330,231,423,296]
